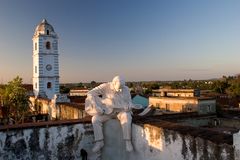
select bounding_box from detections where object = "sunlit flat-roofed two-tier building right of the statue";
[149,89,216,114]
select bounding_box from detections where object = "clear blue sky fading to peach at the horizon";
[0,0,240,83]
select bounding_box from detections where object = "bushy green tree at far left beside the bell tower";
[1,76,31,123]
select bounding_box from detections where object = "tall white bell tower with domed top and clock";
[32,19,59,99]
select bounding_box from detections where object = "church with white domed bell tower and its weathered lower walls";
[29,19,86,120]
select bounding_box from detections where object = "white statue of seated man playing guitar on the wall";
[85,76,138,152]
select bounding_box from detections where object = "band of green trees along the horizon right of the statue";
[123,75,240,97]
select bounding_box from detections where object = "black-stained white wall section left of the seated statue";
[0,124,99,160]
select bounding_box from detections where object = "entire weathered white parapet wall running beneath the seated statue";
[0,117,237,160]
